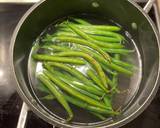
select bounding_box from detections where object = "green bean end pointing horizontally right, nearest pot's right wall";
[102,48,134,55]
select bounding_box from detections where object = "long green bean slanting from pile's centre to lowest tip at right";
[80,47,133,75]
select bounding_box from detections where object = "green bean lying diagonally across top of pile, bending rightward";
[67,24,123,49]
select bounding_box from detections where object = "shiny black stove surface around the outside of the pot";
[0,4,160,128]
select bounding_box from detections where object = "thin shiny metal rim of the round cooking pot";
[9,0,160,128]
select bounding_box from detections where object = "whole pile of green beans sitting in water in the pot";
[32,18,135,122]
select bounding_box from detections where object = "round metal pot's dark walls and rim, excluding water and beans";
[10,0,160,128]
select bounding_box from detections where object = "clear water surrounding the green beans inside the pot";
[28,16,142,123]
